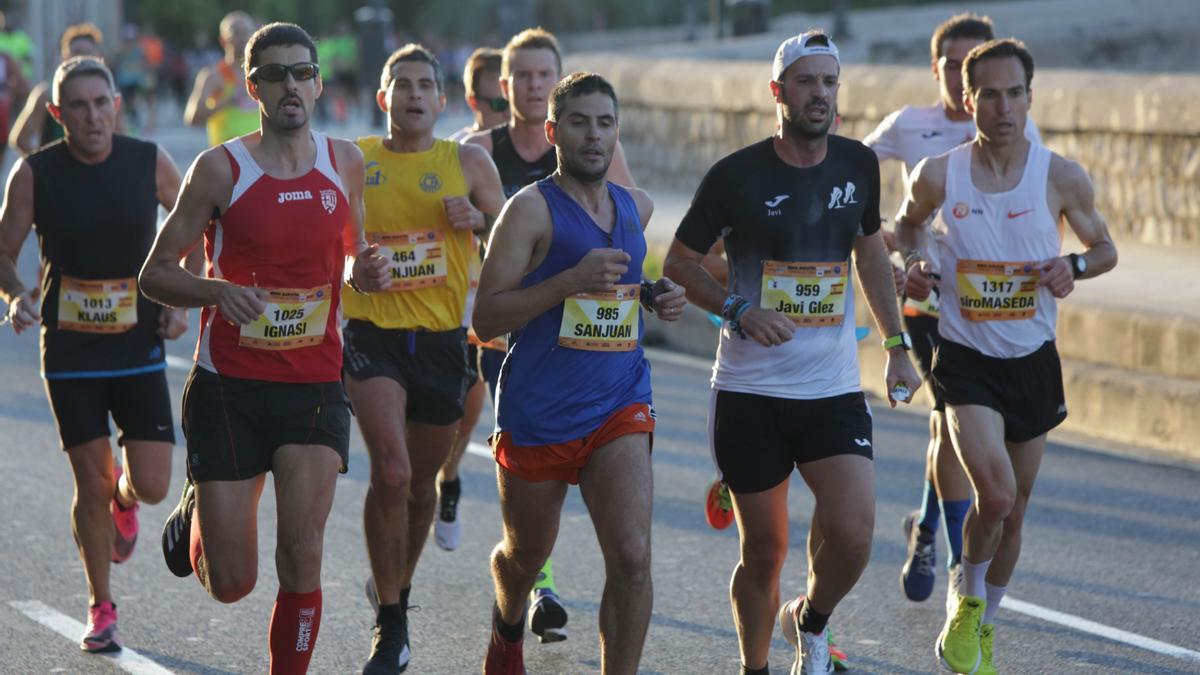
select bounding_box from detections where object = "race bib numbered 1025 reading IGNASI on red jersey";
[238,283,334,351]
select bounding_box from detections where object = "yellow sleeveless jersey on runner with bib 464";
[342,136,474,330]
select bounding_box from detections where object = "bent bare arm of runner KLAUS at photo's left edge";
[0,160,42,333]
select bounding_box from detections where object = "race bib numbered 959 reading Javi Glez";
[760,261,850,328]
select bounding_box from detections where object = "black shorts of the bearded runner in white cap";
[713,392,874,494]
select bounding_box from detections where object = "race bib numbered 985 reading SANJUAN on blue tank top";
[558,283,641,352]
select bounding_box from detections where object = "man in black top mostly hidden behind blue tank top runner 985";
[466,28,634,643]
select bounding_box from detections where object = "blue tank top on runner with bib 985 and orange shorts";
[496,178,652,446]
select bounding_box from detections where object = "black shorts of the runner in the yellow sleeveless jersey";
[342,318,474,425]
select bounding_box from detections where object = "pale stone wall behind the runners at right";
[566,55,1200,247]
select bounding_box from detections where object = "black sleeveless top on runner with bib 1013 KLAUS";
[26,136,166,380]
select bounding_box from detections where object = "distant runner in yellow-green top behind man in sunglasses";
[184,11,259,147]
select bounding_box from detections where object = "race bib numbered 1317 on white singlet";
[958,259,1042,322]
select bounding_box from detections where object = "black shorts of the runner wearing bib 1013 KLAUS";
[46,370,175,450]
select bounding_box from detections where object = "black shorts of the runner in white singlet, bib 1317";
[931,339,1067,443]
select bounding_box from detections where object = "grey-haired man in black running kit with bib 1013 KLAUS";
[0,58,188,652]
